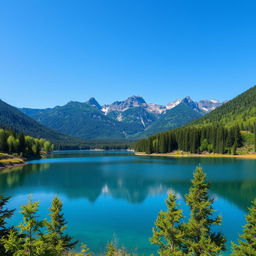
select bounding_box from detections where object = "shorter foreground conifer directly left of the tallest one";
[150,192,185,256]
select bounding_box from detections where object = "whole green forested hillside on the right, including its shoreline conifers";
[134,87,256,154]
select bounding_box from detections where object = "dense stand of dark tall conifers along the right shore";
[134,125,245,154]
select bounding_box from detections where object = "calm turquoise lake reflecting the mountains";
[0,151,256,255]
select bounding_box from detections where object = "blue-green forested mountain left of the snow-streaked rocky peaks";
[22,101,124,139]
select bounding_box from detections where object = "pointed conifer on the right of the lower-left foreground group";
[44,197,77,256]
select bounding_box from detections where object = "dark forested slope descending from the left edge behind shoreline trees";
[0,100,76,143]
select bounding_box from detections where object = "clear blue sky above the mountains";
[0,0,256,108]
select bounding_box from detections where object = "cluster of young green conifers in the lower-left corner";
[0,197,79,256]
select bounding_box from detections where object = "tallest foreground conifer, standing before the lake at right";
[185,168,225,256]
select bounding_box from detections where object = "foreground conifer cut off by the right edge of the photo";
[232,200,256,256]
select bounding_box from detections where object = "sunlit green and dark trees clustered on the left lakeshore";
[0,129,53,157]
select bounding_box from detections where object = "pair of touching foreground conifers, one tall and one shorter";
[151,168,225,256]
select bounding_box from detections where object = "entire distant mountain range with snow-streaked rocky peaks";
[20,96,222,139]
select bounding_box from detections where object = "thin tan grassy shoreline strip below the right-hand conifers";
[134,152,256,159]
